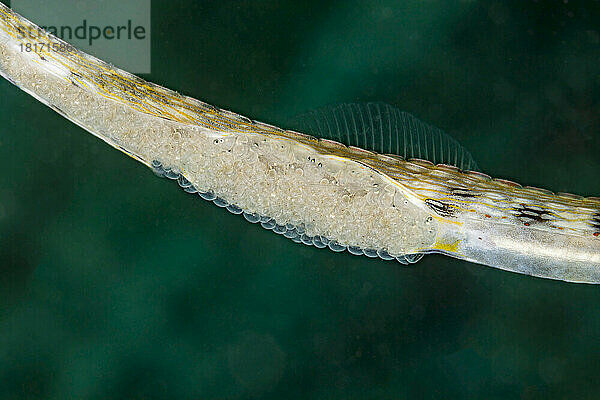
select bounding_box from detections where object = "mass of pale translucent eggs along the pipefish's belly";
[0,31,437,258]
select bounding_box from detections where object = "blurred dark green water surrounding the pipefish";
[0,0,600,399]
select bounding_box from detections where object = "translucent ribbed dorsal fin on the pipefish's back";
[286,103,478,171]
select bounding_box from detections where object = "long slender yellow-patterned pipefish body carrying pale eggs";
[0,3,600,283]
